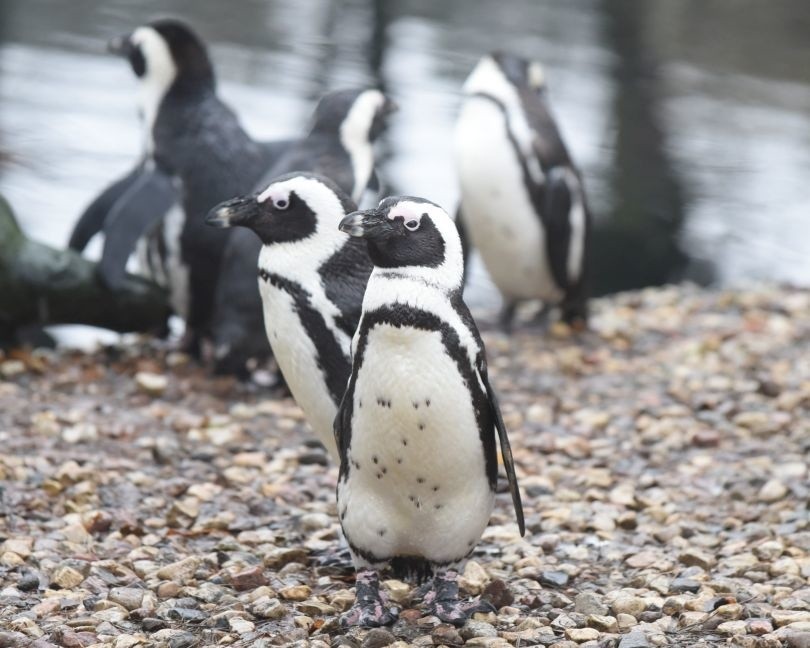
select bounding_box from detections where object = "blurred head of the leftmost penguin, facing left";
[108,18,214,88]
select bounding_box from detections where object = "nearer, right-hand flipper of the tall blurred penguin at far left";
[98,167,177,289]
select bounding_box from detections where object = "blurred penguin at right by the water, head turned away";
[454,52,591,326]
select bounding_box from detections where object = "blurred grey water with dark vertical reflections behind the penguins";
[0,0,810,301]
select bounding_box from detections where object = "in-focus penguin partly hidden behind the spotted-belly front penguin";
[207,173,371,460]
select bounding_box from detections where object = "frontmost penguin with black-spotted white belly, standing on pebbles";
[335,197,524,626]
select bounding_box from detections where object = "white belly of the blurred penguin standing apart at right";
[455,98,562,302]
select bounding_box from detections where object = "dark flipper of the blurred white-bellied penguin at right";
[543,167,573,289]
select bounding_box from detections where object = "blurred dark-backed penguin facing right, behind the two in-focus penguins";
[212,88,394,377]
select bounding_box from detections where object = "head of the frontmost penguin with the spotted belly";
[340,196,461,268]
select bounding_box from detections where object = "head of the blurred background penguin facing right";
[312,89,396,142]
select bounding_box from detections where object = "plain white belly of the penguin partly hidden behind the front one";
[259,281,338,463]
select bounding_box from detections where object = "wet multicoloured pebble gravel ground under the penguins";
[0,287,810,648]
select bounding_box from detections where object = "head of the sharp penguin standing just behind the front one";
[205,173,356,245]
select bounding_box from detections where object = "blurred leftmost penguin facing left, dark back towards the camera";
[93,19,287,364]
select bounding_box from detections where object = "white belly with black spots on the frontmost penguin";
[338,325,494,562]
